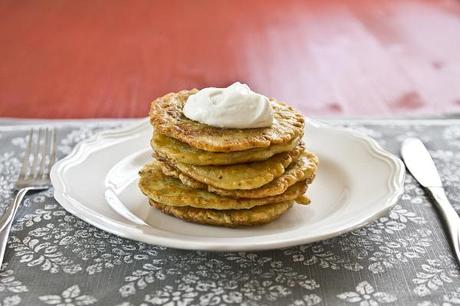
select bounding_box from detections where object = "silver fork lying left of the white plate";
[0,128,56,267]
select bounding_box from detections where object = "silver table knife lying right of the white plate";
[401,138,460,263]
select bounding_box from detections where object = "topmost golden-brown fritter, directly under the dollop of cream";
[150,89,304,152]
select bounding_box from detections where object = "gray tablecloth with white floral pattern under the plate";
[0,120,460,306]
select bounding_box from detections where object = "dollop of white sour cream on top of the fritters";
[183,82,273,129]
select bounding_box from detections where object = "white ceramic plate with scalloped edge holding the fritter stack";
[51,120,405,251]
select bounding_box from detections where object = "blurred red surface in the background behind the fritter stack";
[0,0,460,118]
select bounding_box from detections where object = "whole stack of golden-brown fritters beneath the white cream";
[139,85,318,227]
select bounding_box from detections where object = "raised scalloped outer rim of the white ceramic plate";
[50,118,405,251]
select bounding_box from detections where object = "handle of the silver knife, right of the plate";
[428,187,460,263]
